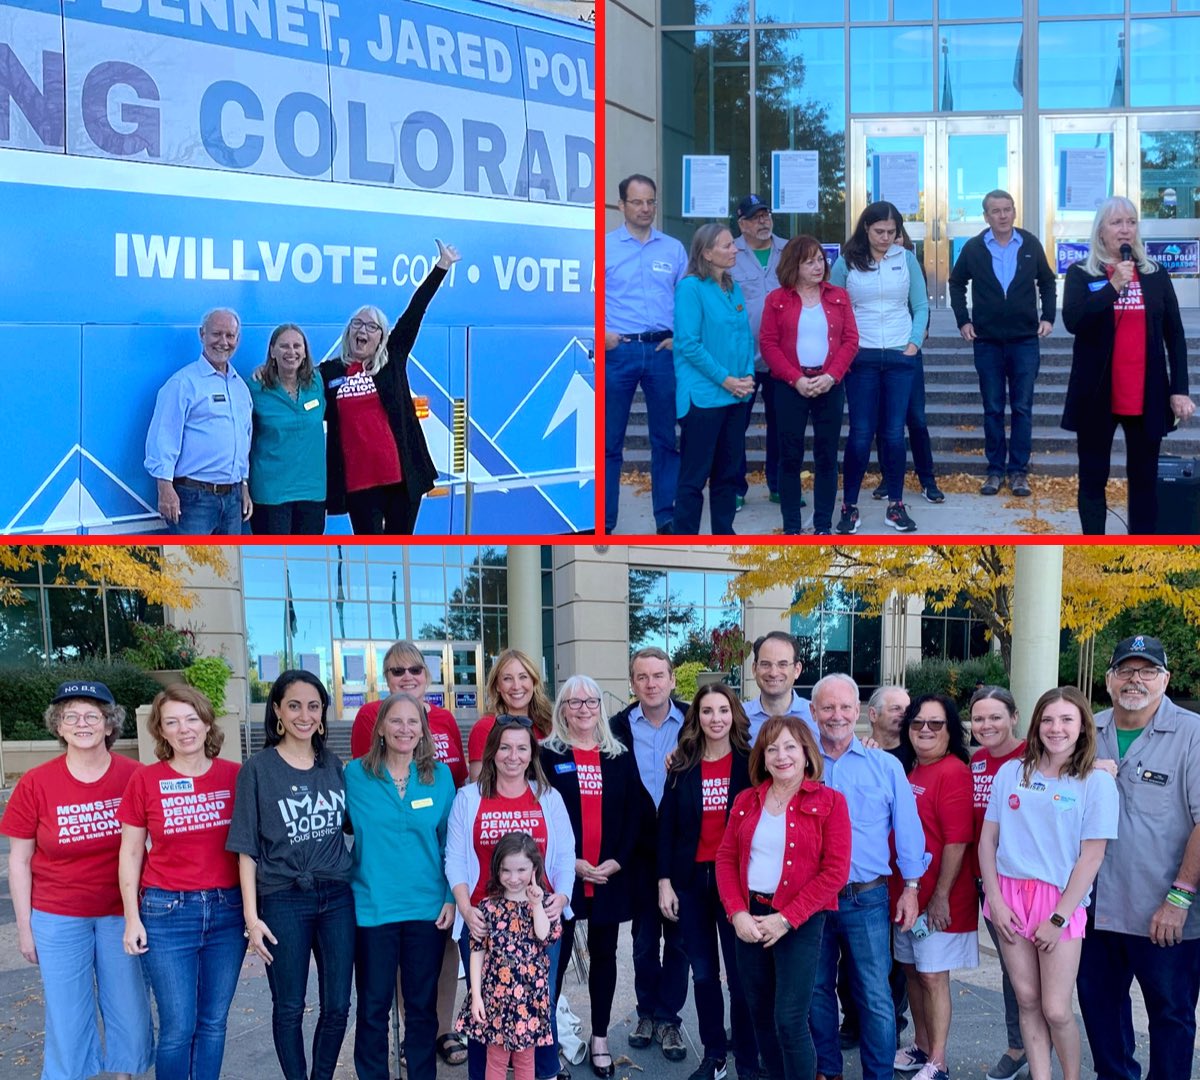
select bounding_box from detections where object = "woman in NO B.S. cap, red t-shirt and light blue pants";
[0,680,154,1080]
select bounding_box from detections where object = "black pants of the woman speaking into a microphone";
[1076,415,1163,536]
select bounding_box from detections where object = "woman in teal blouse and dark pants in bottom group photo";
[344,692,455,1080]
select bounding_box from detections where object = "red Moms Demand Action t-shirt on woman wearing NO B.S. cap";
[0,754,138,919]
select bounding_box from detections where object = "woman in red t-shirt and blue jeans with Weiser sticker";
[116,685,246,1080]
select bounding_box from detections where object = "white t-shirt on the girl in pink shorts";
[986,761,1121,907]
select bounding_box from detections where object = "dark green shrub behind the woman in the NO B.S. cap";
[0,660,162,739]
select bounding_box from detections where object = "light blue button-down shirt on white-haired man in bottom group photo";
[822,736,931,881]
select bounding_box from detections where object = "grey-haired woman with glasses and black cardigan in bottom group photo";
[541,676,653,1078]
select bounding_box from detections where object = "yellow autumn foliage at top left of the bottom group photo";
[0,544,229,610]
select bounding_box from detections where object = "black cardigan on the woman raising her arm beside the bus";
[320,266,446,514]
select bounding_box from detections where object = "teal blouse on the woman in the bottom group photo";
[344,757,455,926]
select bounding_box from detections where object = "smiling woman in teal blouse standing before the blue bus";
[250,323,325,536]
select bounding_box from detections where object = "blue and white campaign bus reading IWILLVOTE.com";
[0,0,595,534]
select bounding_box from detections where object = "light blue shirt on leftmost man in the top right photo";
[604,224,688,334]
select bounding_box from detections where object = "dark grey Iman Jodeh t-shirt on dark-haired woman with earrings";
[226,746,350,895]
